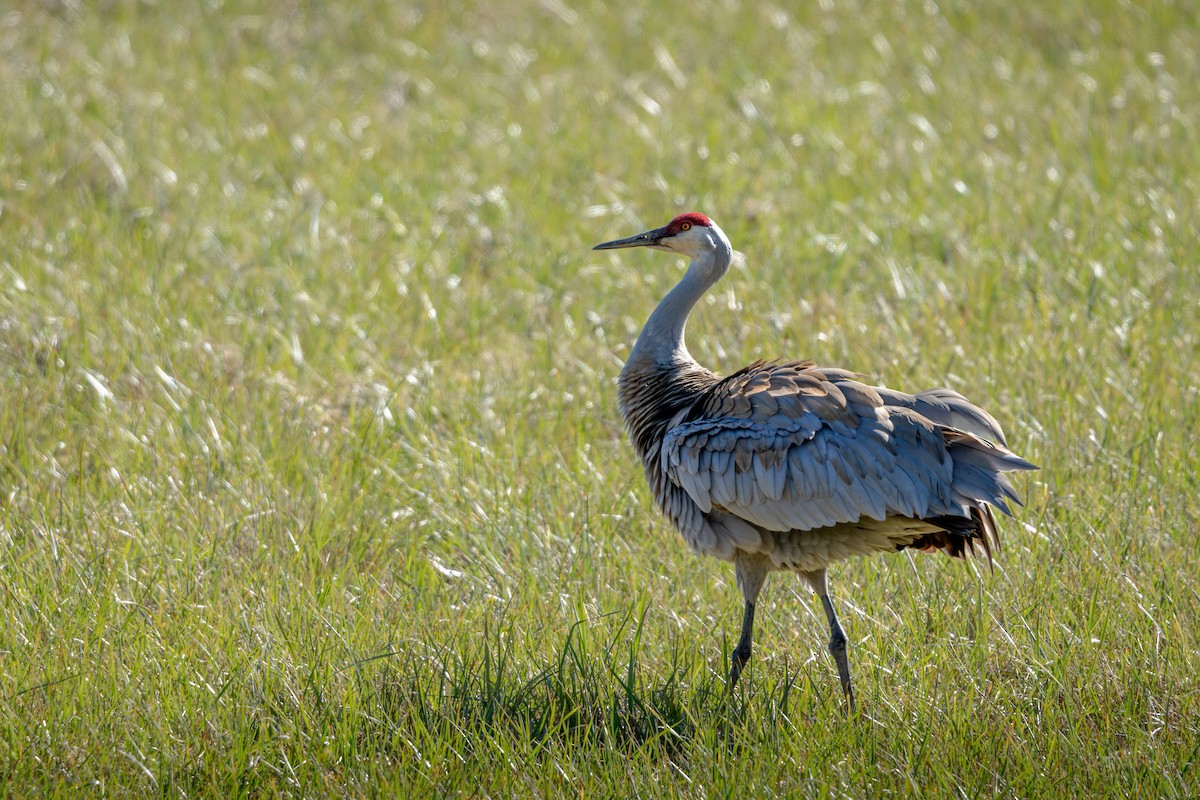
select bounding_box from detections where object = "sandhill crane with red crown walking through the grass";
[594,212,1037,708]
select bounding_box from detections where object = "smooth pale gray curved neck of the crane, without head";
[626,232,733,365]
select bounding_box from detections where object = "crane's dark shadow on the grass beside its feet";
[360,608,806,760]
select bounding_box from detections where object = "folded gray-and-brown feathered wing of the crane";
[659,363,1033,543]
